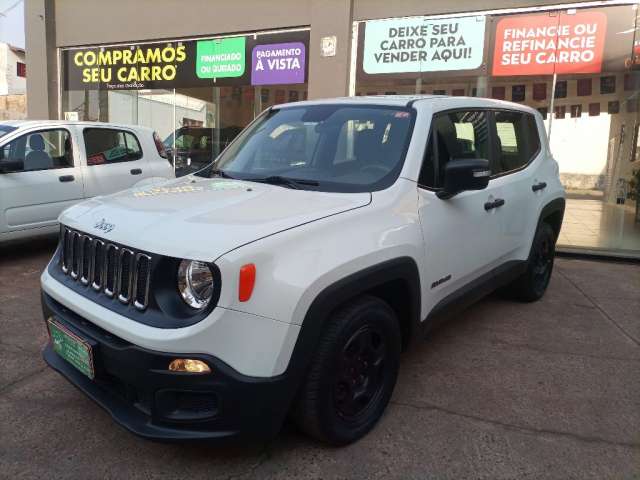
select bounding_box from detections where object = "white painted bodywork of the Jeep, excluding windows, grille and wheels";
[42,97,564,438]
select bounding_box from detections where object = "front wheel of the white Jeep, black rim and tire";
[293,295,401,445]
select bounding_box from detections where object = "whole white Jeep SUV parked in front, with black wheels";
[42,96,565,445]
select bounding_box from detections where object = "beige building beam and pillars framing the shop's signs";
[25,0,616,118]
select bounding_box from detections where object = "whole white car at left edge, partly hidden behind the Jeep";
[0,121,174,243]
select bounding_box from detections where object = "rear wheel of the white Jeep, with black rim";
[507,222,556,302]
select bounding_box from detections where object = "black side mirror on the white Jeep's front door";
[436,158,491,200]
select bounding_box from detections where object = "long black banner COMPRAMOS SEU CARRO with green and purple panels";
[62,30,309,90]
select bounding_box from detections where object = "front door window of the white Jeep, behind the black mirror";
[419,110,490,188]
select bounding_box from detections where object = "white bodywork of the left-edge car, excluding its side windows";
[0,120,175,243]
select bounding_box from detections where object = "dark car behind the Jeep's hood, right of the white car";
[163,126,242,177]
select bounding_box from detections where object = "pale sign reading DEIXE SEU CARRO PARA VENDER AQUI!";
[363,16,486,74]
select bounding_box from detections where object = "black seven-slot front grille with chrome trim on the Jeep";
[60,226,151,310]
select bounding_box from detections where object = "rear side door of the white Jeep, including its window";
[492,110,546,259]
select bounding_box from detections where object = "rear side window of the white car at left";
[83,128,142,165]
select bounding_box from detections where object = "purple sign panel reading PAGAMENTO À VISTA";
[251,42,306,85]
